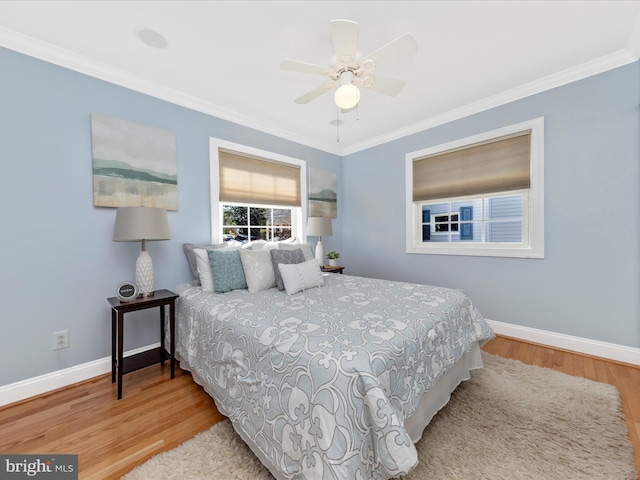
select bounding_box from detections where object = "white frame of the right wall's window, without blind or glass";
[405,117,544,258]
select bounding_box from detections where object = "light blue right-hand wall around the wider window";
[342,63,640,348]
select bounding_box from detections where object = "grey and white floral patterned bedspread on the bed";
[176,274,493,480]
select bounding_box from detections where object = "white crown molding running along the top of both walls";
[0,27,640,156]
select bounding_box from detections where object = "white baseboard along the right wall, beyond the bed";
[487,320,640,366]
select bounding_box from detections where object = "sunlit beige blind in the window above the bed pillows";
[218,149,302,207]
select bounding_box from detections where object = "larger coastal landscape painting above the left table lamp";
[91,113,178,210]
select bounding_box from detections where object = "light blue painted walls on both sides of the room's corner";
[0,49,640,385]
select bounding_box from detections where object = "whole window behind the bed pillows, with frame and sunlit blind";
[210,138,307,243]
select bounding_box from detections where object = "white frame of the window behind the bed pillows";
[209,137,307,244]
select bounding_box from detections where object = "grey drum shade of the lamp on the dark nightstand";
[113,207,171,242]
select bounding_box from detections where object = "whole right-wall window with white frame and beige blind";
[406,118,544,258]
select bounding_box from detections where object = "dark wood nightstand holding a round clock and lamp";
[107,290,178,400]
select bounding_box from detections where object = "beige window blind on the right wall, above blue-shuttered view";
[413,131,531,202]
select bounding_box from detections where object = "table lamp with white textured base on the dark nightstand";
[113,207,171,297]
